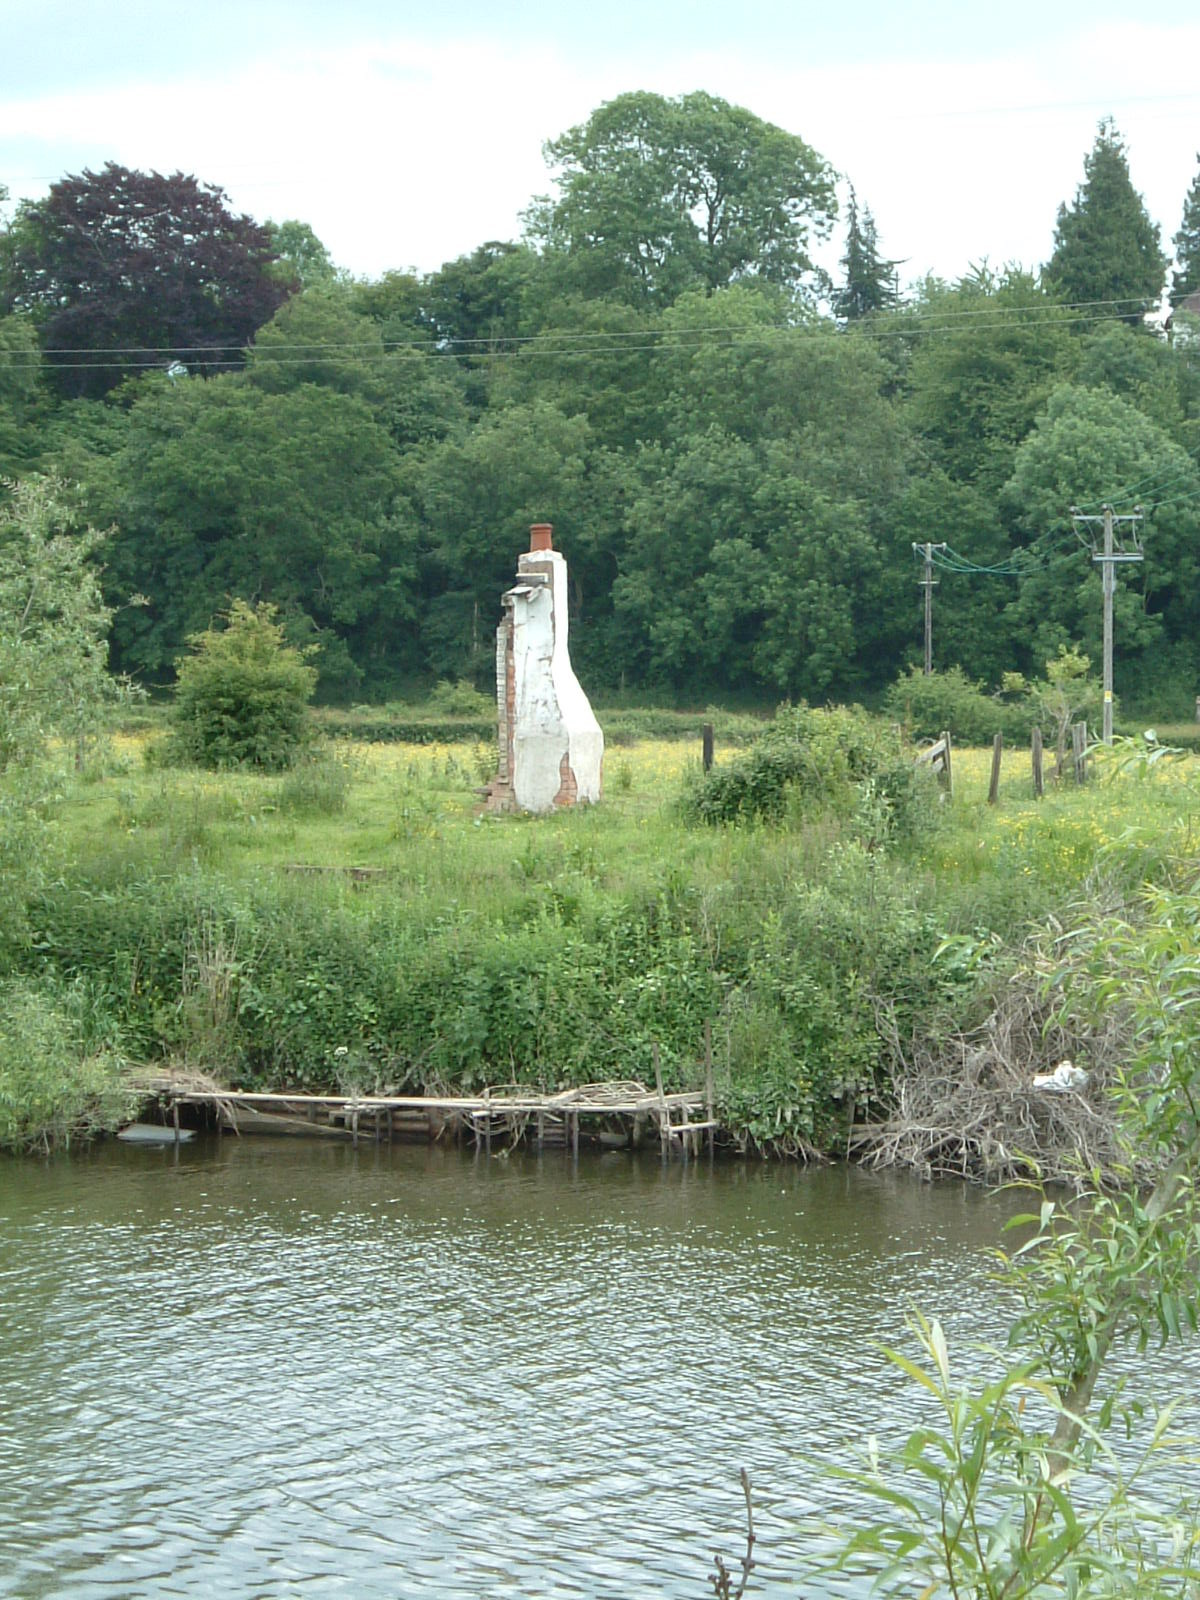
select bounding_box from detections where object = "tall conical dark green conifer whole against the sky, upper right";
[1045,117,1166,323]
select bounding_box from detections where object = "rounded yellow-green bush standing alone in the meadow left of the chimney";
[168,600,317,771]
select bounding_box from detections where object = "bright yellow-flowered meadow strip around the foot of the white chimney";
[59,734,1200,904]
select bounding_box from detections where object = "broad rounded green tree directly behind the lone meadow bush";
[95,374,406,690]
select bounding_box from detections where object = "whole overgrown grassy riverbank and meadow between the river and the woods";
[5,734,1197,1150]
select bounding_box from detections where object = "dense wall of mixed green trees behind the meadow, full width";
[0,108,1200,713]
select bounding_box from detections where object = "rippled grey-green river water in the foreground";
[0,1139,1196,1600]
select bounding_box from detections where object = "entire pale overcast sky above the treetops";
[0,0,1200,289]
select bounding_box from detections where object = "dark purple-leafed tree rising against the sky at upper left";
[0,162,296,397]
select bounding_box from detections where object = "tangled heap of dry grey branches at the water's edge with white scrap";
[853,944,1154,1189]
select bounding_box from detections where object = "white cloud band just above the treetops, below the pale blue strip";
[0,22,1200,284]
